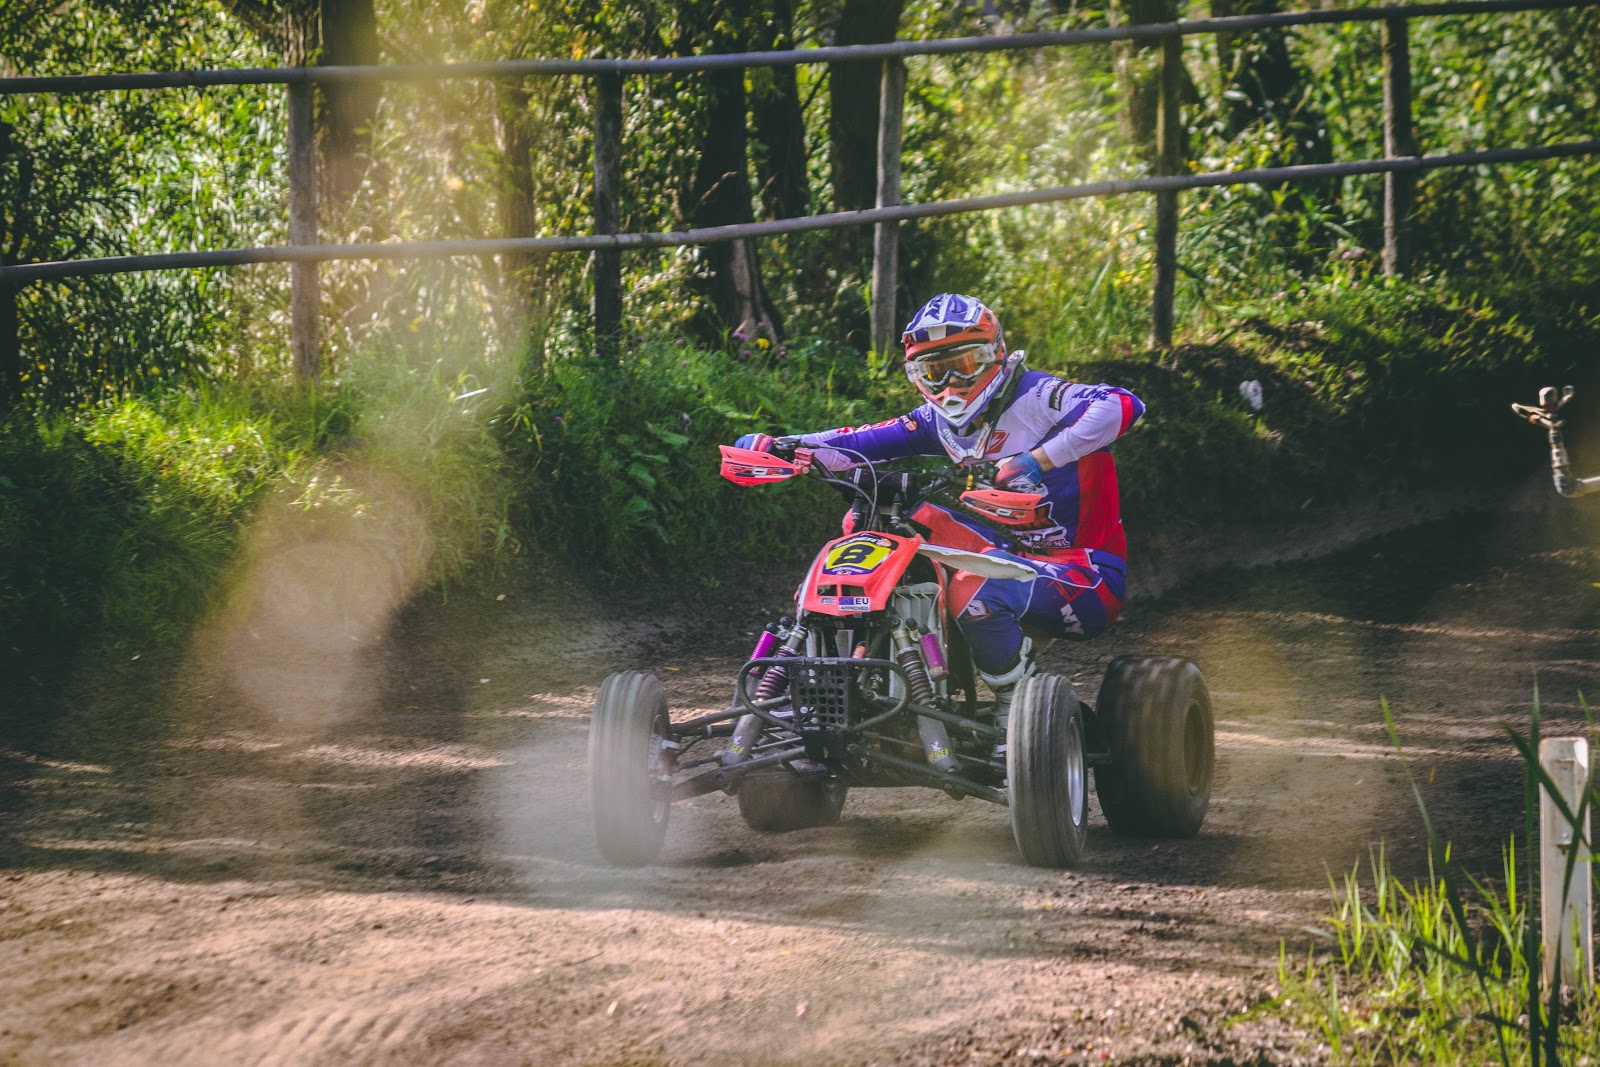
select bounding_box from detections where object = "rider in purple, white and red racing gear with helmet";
[738,293,1144,739]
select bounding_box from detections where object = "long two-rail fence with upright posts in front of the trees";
[0,0,1600,378]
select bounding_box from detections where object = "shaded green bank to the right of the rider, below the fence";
[1030,275,1600,544]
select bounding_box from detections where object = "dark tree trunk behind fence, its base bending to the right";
[691,67,778,338]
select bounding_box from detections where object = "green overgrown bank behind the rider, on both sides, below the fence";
[0,268,1600,675]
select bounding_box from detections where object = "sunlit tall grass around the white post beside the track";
[1269,691,1600,1067]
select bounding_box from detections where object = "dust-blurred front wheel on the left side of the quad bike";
[589,670,672,867]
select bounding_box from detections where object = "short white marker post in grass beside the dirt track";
[1539,737,1594,992]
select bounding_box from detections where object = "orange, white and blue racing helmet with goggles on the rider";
[901,293,1022,434]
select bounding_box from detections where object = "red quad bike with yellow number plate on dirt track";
[589,438,1214,867]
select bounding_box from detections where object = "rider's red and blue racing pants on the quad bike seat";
[912,504,1128,675]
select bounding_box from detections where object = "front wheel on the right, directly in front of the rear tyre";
[1006,675,1090,867]
